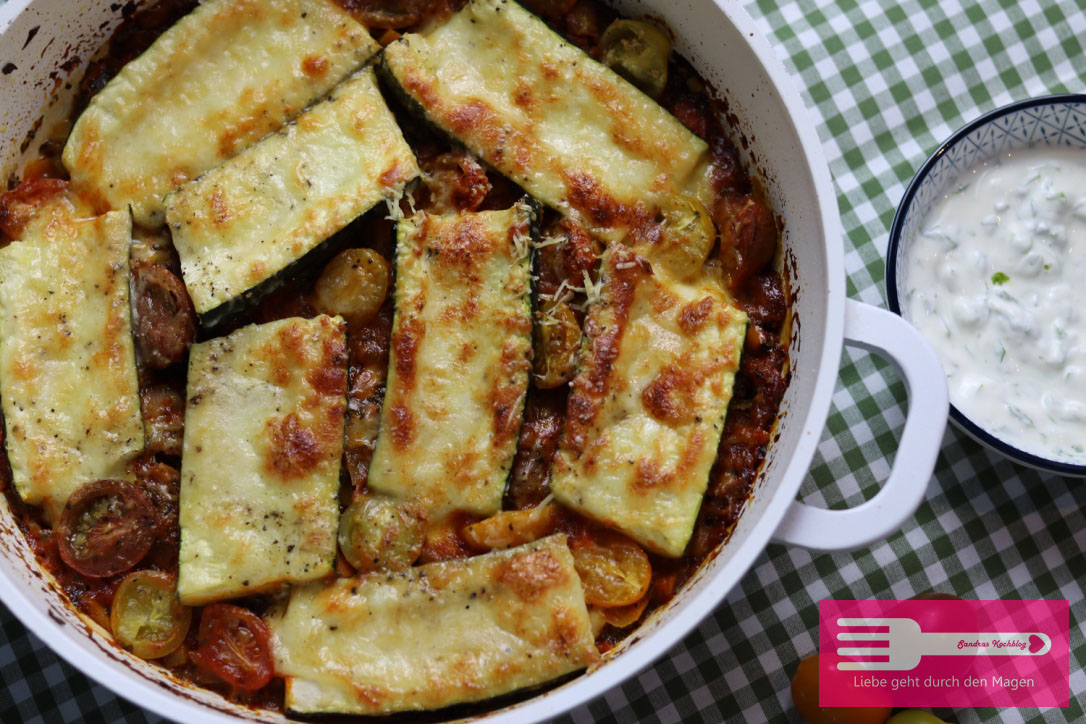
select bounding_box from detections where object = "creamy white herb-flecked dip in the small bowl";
[901,148,1086,465]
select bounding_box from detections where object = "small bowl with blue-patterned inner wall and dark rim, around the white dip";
[886,93,1086,478]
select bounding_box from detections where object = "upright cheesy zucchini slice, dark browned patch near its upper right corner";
[177,316,346,605]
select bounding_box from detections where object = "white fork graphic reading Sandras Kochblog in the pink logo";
[837,619,1052,671]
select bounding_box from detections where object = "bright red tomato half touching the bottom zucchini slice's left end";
[190,604,274,691]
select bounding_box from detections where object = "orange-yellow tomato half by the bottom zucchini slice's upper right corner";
[570,533,653,608]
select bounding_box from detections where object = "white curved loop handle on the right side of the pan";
[774,300,949,550]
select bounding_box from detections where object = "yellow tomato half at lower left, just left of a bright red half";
[110,571,192,659]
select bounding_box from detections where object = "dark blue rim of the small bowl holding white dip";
[886,93,1086,478]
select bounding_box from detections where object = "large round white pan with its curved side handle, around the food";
[0,0,947,724]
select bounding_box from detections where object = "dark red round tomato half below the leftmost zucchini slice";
[56,480,159,579]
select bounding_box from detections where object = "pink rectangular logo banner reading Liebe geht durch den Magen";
[819,600,1070,707]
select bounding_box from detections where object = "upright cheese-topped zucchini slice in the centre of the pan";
[369,201,533,516]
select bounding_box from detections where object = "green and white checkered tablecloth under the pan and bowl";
[0,0,1086,724]
